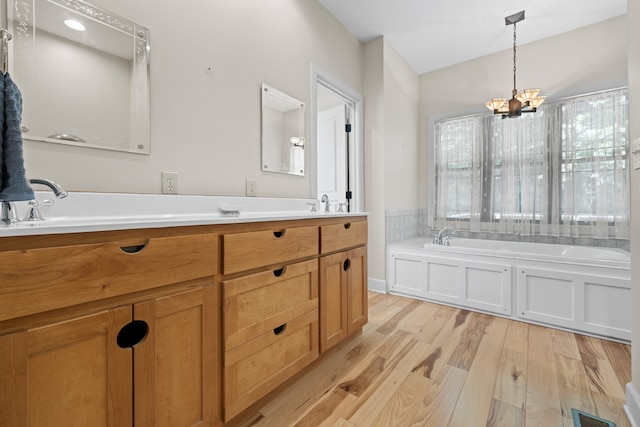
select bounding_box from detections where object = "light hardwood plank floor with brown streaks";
[230,293,631,427]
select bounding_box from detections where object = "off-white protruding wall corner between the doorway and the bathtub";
[364,37,418,289]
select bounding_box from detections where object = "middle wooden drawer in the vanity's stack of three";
[222,259,318,350]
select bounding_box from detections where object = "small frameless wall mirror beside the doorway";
[262,84,305,175]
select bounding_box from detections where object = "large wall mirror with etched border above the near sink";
[7,0,150,154]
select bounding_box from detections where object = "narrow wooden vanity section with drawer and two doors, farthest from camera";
[320,221,368,352]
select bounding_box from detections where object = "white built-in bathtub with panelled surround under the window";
[387,238,631,341]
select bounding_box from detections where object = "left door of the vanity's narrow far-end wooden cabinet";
[320,252,349,352]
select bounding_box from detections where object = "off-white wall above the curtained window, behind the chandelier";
[419,16,627,212]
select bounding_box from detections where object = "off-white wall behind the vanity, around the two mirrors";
[18,0,362,197]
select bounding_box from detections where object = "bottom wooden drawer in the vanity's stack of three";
[224,310,318,421]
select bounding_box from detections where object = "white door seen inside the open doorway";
[317,104,347,211]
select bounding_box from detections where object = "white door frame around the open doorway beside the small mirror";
[307,64,364,212]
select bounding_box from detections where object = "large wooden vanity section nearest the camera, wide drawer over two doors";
[0,231,220,427]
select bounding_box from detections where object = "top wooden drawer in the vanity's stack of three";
[222,227,318,274]
